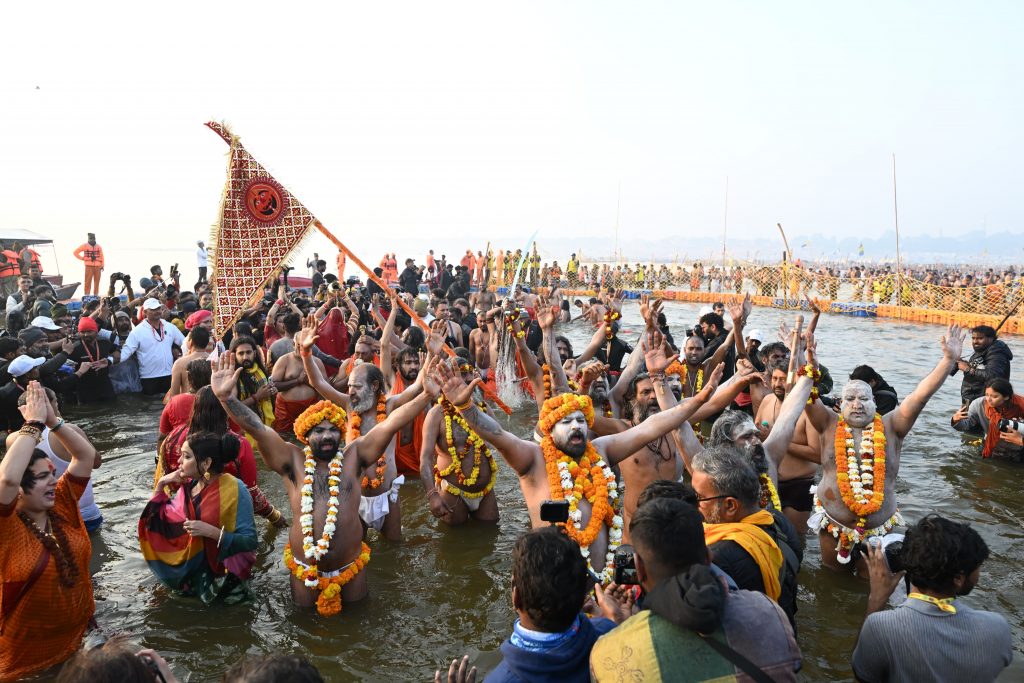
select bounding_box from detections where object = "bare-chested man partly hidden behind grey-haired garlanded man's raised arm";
[754,359,821,537]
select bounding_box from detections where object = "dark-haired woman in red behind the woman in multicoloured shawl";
[154,386,288,528]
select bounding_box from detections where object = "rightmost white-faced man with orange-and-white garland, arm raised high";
[807,325,966,571]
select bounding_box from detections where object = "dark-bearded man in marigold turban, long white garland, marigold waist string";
[210,353,438,615]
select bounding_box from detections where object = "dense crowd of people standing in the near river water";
[0,236,1011,682]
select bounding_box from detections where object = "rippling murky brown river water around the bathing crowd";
[28,303,1024,681]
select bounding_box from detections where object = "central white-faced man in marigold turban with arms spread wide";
[437,362,718,584]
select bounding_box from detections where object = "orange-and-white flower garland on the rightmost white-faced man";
[835,413,886,561]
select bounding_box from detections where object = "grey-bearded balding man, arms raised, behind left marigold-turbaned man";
[295,316,425,541]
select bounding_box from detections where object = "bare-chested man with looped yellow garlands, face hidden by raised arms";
[420,358,498,525]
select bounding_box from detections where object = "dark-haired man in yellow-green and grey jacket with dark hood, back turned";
[590,499,802,682]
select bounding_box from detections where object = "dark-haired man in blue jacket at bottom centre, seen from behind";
[484,526,615,683]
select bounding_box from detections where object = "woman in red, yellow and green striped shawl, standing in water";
[138,432,256,604]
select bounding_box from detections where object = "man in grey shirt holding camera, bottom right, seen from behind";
[851,514,1013,683]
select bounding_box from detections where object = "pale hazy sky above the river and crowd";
[0,2,1024,272]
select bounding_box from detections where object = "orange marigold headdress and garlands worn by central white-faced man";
[538,393,623,585]
